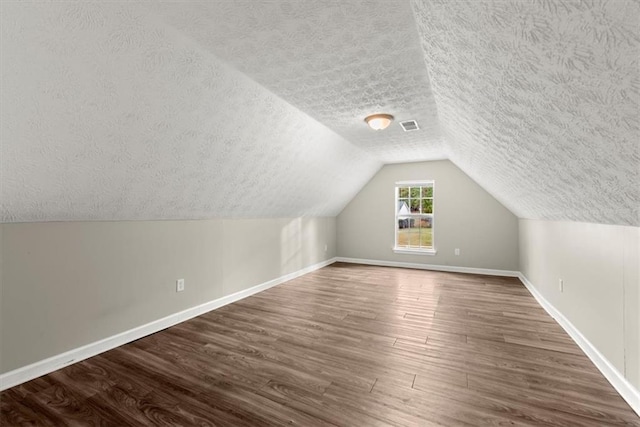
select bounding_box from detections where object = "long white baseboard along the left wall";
[0,258,336,390]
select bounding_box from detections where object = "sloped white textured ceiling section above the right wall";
[413,0,640,225]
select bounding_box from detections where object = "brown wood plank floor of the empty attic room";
[0,263,640,426]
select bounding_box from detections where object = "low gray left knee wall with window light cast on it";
[0,218,336,373]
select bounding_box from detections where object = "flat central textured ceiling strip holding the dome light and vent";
[156,0,445,163]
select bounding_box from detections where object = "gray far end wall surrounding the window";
[338,160,518,271]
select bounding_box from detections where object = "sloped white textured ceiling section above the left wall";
[1,2,381,222]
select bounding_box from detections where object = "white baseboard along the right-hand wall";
[518,273,640,416]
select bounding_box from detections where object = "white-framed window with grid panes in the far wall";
[394,181,436,255]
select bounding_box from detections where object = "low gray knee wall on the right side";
[519,219,640,389]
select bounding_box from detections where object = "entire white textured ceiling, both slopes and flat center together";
[0,0,640,225]
